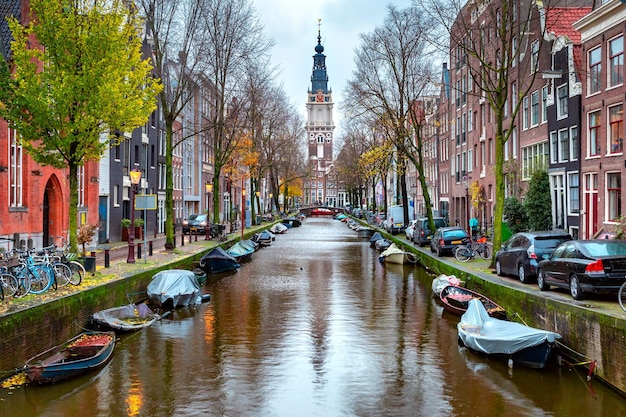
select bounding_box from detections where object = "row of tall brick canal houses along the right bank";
[409,0,626,239]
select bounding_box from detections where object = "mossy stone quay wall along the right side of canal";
[386,235,626,396]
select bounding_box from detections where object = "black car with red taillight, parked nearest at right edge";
[537,239,626,300]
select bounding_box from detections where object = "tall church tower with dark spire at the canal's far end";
[304,19,337,206]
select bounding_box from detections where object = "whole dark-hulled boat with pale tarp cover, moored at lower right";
[457,298,561,368]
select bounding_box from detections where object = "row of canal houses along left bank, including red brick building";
[0,0,241,250]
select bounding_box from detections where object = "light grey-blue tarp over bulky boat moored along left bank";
[147,269,202,307]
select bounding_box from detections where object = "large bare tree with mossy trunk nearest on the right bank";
[422,0,590,264]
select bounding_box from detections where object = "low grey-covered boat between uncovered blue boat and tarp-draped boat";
[91,303,161,332]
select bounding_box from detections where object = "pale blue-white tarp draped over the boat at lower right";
[457,298,561,354]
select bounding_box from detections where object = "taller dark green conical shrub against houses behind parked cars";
[524,170,552,230]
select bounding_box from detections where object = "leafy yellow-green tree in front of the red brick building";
[0,0,160,251]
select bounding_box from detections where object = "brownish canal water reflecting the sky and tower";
[0,218,626,417]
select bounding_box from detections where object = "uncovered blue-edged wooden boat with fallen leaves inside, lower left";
[24,332,115,384]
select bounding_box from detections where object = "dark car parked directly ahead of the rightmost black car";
[496,230,572,283]
